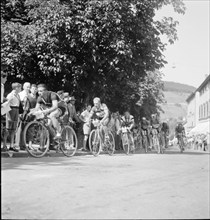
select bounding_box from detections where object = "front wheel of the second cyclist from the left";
[89,129,101,157]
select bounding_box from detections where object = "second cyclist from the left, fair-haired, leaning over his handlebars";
[89,97,110,145]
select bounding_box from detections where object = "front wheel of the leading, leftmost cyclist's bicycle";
[23,121,50,157]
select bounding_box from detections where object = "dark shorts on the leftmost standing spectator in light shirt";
[6,106,19,130]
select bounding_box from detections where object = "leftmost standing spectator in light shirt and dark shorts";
[4,83,22,152]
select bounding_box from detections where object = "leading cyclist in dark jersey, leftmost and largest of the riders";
[30,84,66,140]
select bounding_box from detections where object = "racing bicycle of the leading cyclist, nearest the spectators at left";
[23,113,78,158]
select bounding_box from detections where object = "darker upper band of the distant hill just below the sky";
[164,81,196,93]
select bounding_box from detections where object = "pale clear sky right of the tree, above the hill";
[156,0,210,88]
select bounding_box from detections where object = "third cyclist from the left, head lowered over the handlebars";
[121,111,135,151]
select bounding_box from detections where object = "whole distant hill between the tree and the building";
[161,81,196,119]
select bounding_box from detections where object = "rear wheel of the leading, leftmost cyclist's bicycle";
[60,125,78,157]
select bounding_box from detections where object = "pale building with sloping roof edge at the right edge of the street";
[185,75,210,134]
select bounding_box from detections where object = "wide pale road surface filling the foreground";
[2,147,210,219]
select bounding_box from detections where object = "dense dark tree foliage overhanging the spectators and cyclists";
[1,0,185,117]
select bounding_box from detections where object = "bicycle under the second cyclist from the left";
[89,119,115,157]
